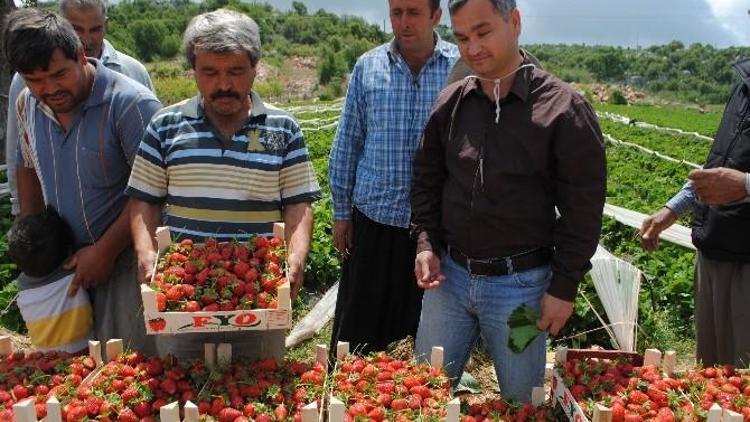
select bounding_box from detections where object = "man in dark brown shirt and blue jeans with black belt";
[411,0,606,401]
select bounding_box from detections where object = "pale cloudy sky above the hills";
[270,0,750,47]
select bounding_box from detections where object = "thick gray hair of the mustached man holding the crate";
[182,9,260,67]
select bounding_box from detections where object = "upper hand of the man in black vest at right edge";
[688,167,747,205]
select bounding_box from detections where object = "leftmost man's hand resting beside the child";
[64,243,116,296]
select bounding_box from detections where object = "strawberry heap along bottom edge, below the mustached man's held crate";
[50,353,324,422]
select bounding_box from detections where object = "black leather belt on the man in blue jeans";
[448,246,552,275]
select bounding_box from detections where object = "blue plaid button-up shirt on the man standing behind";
[328,35,458,228]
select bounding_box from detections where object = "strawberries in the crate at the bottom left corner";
[0,352,96,421]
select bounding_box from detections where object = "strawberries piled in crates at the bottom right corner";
[558,359,750,422]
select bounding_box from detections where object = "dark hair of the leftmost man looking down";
[2,7,81,73]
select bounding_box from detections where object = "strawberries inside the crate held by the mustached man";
[151,237,286,312]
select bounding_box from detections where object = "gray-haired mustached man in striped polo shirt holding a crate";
[126,9,320,357]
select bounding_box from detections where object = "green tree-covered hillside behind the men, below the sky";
[11,0,750,104]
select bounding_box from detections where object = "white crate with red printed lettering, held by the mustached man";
[141,223,292,335]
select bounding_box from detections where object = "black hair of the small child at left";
[8,206,75,277]
